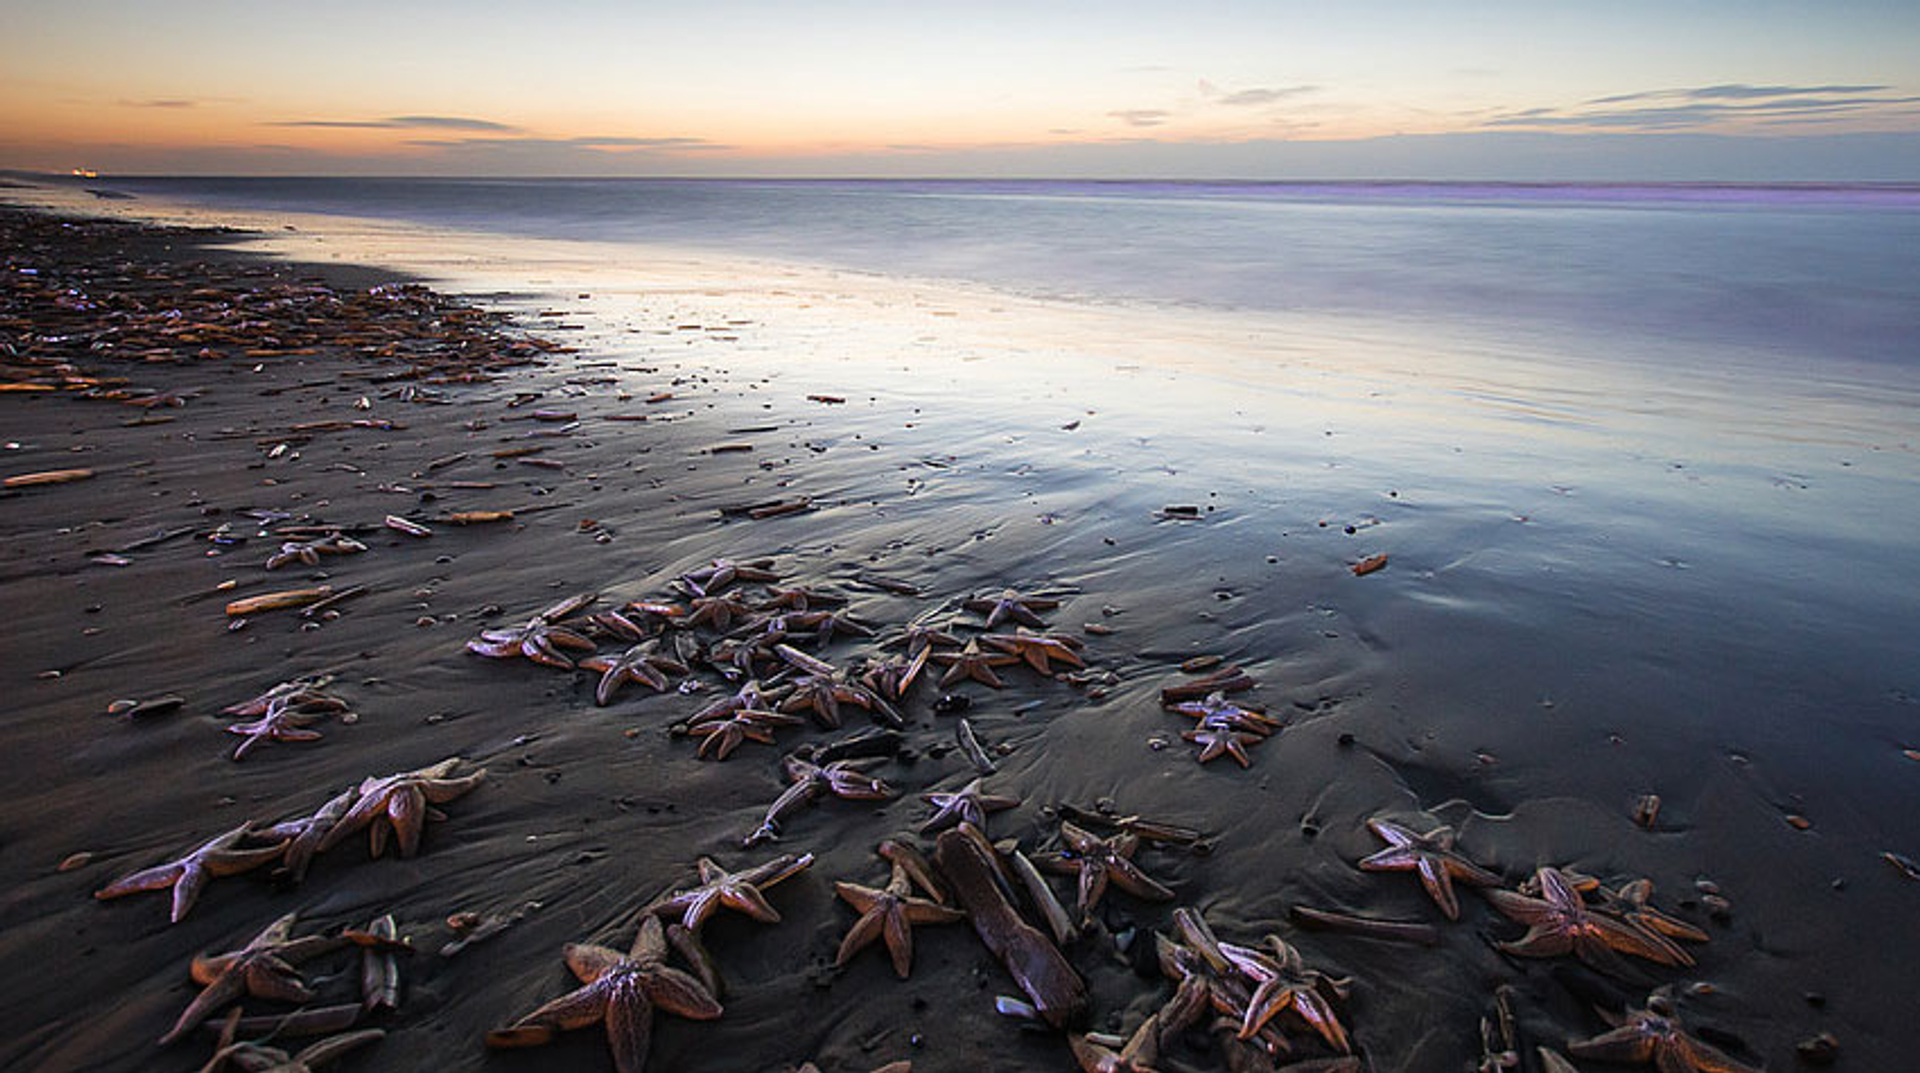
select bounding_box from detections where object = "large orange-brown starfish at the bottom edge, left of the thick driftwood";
[486,914,720,1073]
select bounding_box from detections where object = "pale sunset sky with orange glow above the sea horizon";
[0,0,1920,180]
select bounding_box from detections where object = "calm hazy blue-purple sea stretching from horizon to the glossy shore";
[67,179,1920,370]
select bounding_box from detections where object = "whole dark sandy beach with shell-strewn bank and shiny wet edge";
[0,194,1920,1073]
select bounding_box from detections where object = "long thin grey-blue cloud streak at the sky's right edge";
[1484,83,1920,131]
